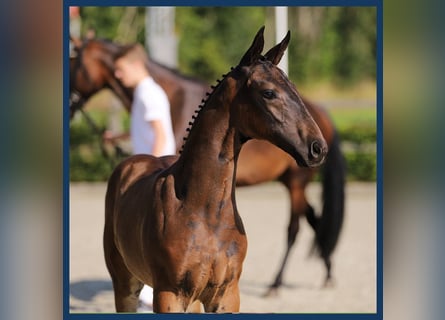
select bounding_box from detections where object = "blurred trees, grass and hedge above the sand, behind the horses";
[70,7,377,181]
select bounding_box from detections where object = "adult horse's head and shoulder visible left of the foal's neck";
[70,38,210,148]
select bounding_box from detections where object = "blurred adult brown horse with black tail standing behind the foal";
[70,33,345,293]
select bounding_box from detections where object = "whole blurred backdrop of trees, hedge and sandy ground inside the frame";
[69,7,381,313]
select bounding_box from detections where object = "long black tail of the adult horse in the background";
[314,132,346,259]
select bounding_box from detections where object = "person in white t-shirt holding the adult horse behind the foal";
[104,44,176,157]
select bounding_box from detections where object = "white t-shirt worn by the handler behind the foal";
[130,77,176,155]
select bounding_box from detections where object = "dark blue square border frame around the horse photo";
[62,0,383,320]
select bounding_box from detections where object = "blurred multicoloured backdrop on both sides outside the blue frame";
[0,0,445,320]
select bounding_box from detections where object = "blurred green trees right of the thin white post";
[289,7,376,86]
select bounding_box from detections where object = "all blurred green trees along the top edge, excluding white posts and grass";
[76,7,376,86]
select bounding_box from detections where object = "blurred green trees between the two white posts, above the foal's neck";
[176,7,265,82]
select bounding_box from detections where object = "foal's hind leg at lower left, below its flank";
[104,225,143,312]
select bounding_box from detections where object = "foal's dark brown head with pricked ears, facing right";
[231,27,327,167]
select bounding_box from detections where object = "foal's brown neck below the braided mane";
[174,73,241,203]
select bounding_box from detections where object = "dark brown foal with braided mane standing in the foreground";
[104,27,327,312]
